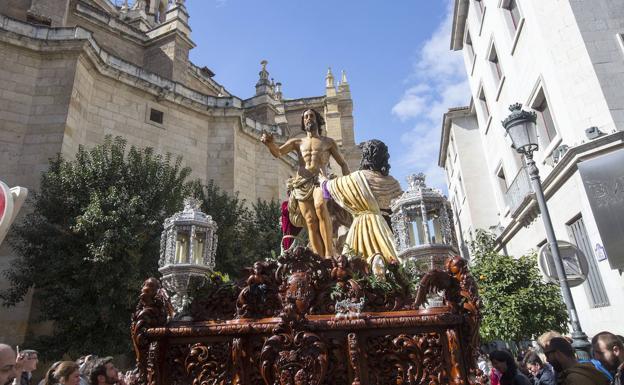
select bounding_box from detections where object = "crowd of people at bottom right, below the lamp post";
[479,331,624,385]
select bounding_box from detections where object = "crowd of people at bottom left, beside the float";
[0,343,134,385]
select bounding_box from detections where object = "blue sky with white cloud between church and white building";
[180,0,470,188]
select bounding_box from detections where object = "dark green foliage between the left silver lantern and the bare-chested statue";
[195,181,282,278]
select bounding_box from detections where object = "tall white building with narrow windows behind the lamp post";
[439,0,624,336]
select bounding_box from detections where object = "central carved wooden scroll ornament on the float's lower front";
[260,332,328,385]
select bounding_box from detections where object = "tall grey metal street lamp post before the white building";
[502,103,591,359]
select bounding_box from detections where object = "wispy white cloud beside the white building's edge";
[392,0,470,190]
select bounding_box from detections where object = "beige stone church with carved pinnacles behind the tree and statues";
[0,0,359,342]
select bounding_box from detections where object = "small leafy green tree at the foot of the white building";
[471,230,568,342]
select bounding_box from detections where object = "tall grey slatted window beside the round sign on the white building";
[567,216,609,308]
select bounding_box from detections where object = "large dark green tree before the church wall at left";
[0,136,191,357]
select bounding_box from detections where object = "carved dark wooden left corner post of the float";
[130,278,173,385]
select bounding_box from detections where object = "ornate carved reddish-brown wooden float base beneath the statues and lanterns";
[132,248,480,385]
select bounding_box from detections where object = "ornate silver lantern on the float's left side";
[158,198,217,320]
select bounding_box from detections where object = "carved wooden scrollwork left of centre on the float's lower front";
[185,341,233,385]
